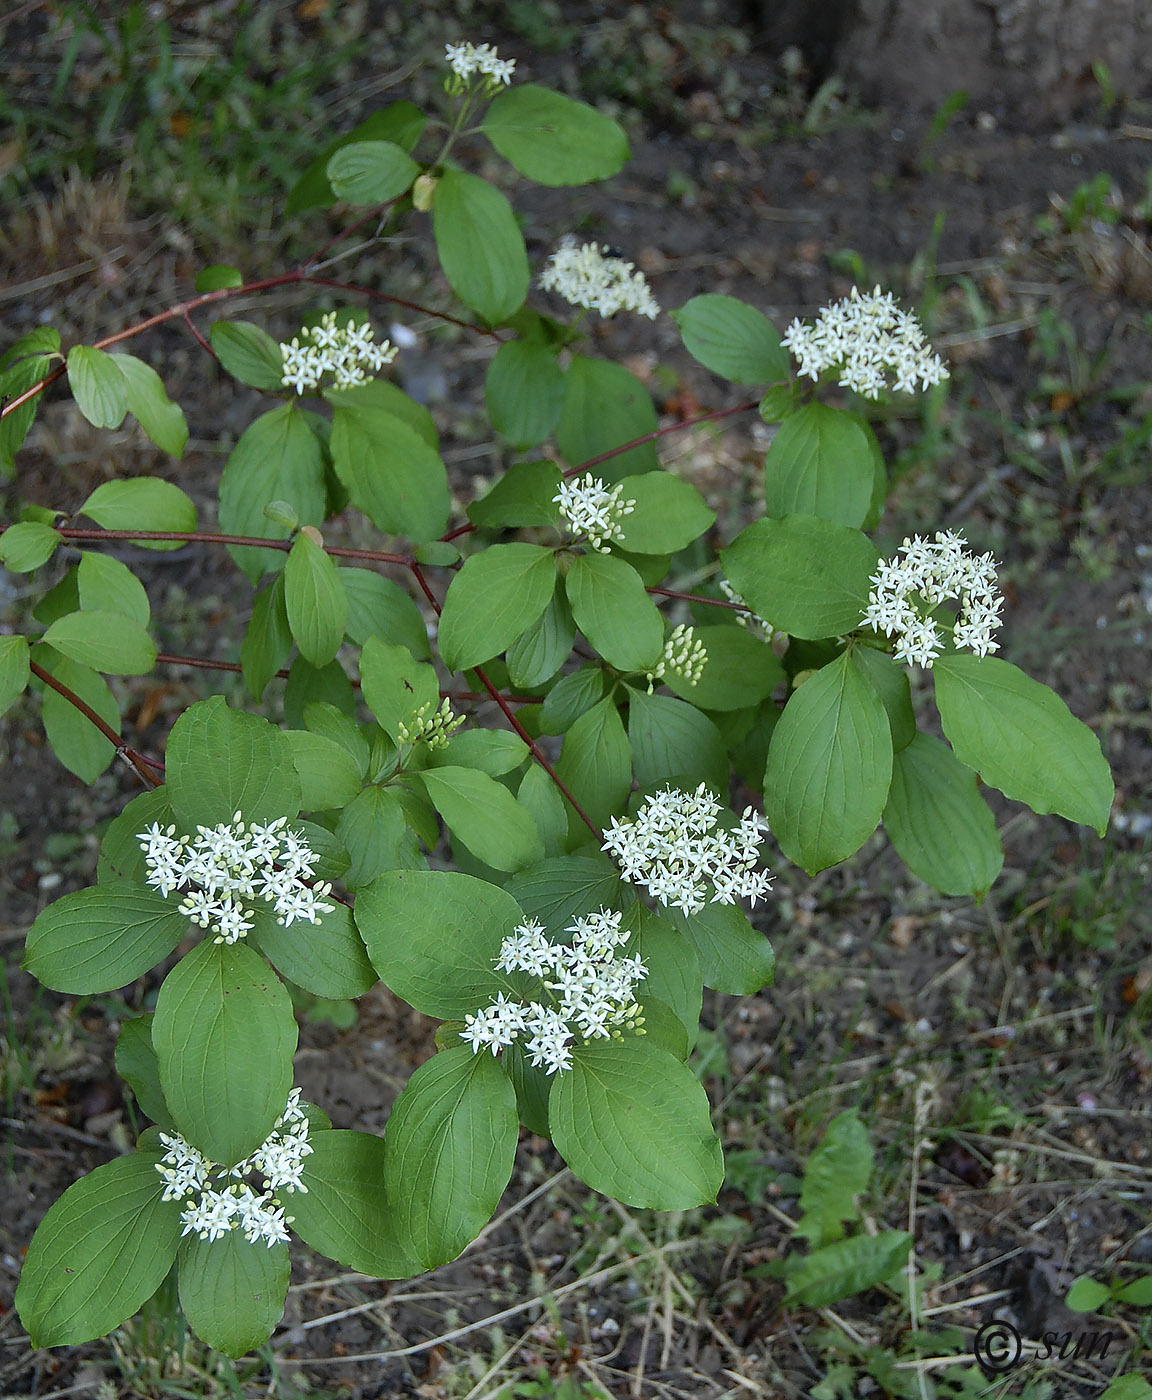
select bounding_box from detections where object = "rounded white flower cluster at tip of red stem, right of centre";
[600,783,771,914]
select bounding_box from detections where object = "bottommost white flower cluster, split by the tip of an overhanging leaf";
[155,1089,314,1249]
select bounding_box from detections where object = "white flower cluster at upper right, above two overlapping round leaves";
[780,287,948,399]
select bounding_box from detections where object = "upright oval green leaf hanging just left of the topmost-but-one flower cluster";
[433,169,529,325]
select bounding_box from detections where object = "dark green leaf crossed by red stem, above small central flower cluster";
[556,354,659,486]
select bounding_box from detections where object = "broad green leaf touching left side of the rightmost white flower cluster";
[719,515,880,641]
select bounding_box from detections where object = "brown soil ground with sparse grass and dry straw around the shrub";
[0,6,1152,1400]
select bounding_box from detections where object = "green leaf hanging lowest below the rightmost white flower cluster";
[883,734,1004,897]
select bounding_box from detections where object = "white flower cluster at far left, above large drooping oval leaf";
[136,812,336,944]
